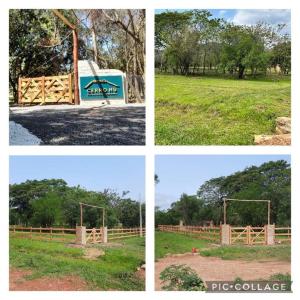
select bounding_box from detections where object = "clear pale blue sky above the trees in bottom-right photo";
[155,155,290,209]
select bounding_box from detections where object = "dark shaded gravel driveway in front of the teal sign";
[10,106,145,145]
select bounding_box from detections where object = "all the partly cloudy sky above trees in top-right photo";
[155,9,291,34]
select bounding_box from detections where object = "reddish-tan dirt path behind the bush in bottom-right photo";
[155,253,291,290]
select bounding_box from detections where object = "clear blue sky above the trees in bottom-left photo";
[9,156,145,201]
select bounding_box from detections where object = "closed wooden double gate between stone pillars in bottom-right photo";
[230,226,267,245]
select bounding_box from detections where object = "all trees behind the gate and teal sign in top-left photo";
[9,9,145,101]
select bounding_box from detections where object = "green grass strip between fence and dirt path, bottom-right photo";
[155,231,291,261]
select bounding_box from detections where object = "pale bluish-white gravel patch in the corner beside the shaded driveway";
[9,121,42,145]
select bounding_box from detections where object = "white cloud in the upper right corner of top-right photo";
[232,9,291,33]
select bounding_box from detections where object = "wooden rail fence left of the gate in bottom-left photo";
[9,226,76,243]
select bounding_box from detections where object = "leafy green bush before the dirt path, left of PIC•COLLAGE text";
[160,265,205,291]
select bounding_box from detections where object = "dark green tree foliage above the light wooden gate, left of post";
[9,9,74,99]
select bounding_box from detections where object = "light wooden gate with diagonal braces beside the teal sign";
[18,74,73,104]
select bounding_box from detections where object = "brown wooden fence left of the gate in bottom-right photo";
[158,225,221,243]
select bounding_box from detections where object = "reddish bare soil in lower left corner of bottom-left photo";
[9,268,88,291]
